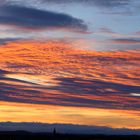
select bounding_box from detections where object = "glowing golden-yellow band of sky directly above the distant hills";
[0,102,140,129]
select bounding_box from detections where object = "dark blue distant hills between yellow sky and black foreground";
[0,122,140,135]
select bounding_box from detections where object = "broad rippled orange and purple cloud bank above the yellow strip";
[0,40,140,110]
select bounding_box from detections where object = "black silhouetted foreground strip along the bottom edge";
[0,131,140,140]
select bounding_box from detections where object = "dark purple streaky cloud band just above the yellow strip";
[0,70,140,110]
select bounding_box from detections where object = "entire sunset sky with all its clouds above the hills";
[0,0,140,132]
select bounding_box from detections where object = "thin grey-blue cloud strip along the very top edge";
[3,0,132,8]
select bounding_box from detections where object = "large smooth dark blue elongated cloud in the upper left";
[0,6,87,31]
